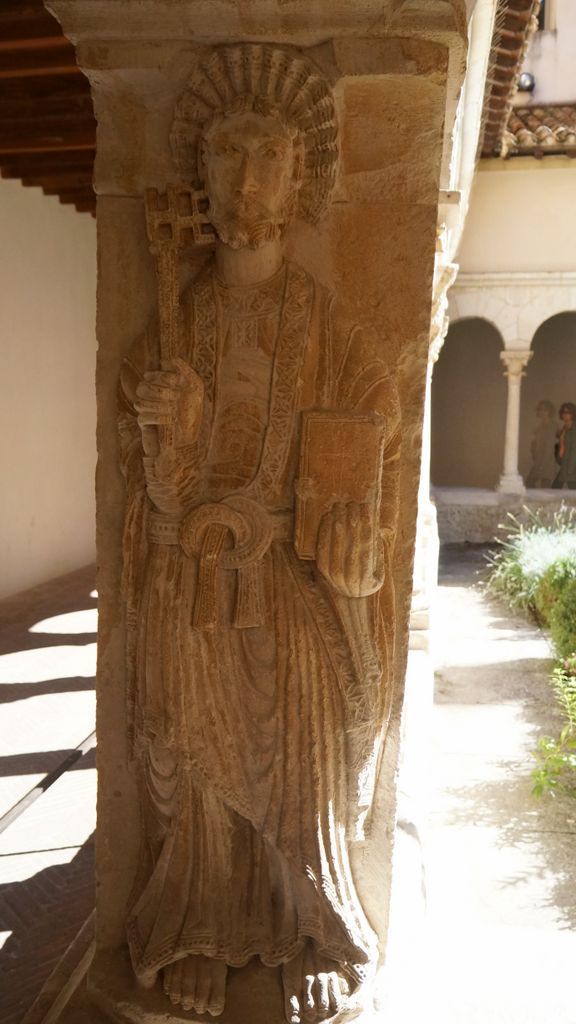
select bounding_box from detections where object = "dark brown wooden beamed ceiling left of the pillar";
[0,0,96,214]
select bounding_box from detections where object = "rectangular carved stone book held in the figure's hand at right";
[294,410,384,559]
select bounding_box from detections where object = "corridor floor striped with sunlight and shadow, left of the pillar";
[0,566,96,1024]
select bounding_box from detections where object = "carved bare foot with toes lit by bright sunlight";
[282,942,349,1024]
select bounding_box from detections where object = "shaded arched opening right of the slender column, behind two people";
[519,312,576,486]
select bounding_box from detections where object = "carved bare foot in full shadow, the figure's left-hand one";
[163,954,228,1017]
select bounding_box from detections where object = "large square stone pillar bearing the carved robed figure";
[43,0,465,1024]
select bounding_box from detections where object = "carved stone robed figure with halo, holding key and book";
[120,44,400,1024]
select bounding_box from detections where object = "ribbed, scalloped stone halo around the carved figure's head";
[170,43,338,223]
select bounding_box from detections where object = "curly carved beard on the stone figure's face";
[208,189,297,249]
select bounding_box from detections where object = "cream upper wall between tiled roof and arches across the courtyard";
[457,157,576,273]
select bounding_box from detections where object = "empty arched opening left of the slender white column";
[430,317,506,488]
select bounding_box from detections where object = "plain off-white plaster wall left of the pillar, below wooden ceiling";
[0,180,96,597]
